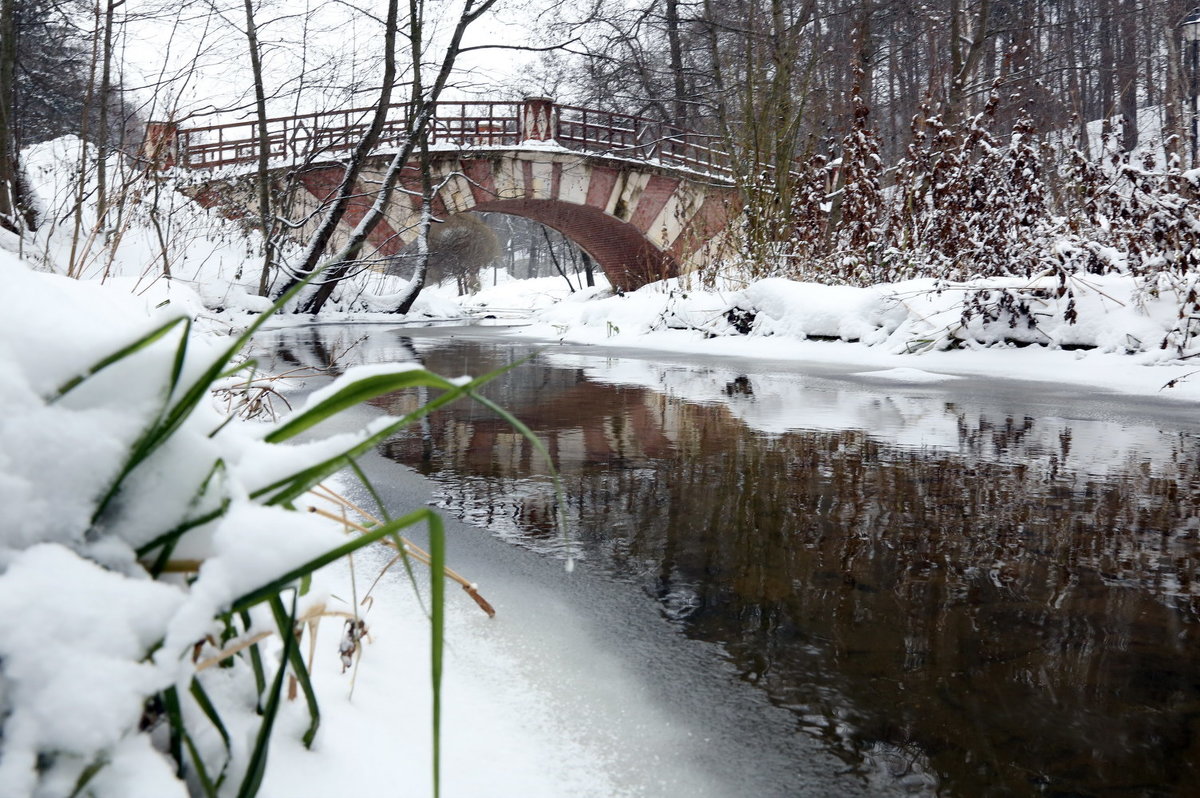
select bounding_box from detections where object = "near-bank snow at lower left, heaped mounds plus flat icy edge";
[0,251,848,798]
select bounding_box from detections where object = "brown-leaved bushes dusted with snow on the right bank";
[745,95,1200,356]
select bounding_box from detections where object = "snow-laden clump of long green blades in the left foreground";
[0,258,496,798]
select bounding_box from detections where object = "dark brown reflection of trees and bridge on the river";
[388,343,1200,794]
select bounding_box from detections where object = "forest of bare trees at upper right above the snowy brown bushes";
[547,0,1194,162]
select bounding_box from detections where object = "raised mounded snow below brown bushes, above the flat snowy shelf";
[535,275,1200,360]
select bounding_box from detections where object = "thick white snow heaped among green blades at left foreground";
[0,252,367,796]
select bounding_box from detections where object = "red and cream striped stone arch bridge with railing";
[146,97,740,290]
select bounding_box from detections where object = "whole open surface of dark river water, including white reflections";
[270,328,1200,797]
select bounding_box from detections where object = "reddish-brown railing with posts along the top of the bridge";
[146,97,731,176]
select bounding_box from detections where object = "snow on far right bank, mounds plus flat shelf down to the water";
[523,275,1200,402]
